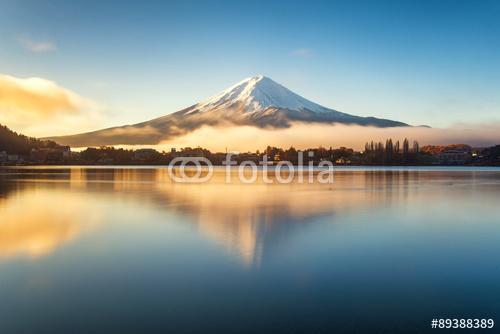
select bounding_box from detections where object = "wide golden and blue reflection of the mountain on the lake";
[71,169,418,264]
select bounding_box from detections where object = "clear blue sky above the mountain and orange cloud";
[0,0,500,134]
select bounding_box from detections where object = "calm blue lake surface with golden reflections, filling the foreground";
[0,167,500,334]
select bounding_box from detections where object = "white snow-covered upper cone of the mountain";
[195,75,331,113]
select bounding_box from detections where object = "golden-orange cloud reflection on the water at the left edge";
[0,190,98,258]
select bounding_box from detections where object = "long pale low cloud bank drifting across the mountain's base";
[158,121,500,151]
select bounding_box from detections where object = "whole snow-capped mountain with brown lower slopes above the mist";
[47,75,409,147]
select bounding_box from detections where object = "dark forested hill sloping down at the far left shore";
[0,124,59,154]
